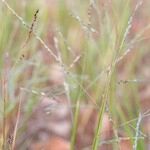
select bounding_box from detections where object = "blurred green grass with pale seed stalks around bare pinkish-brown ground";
[0,0,150,150]
